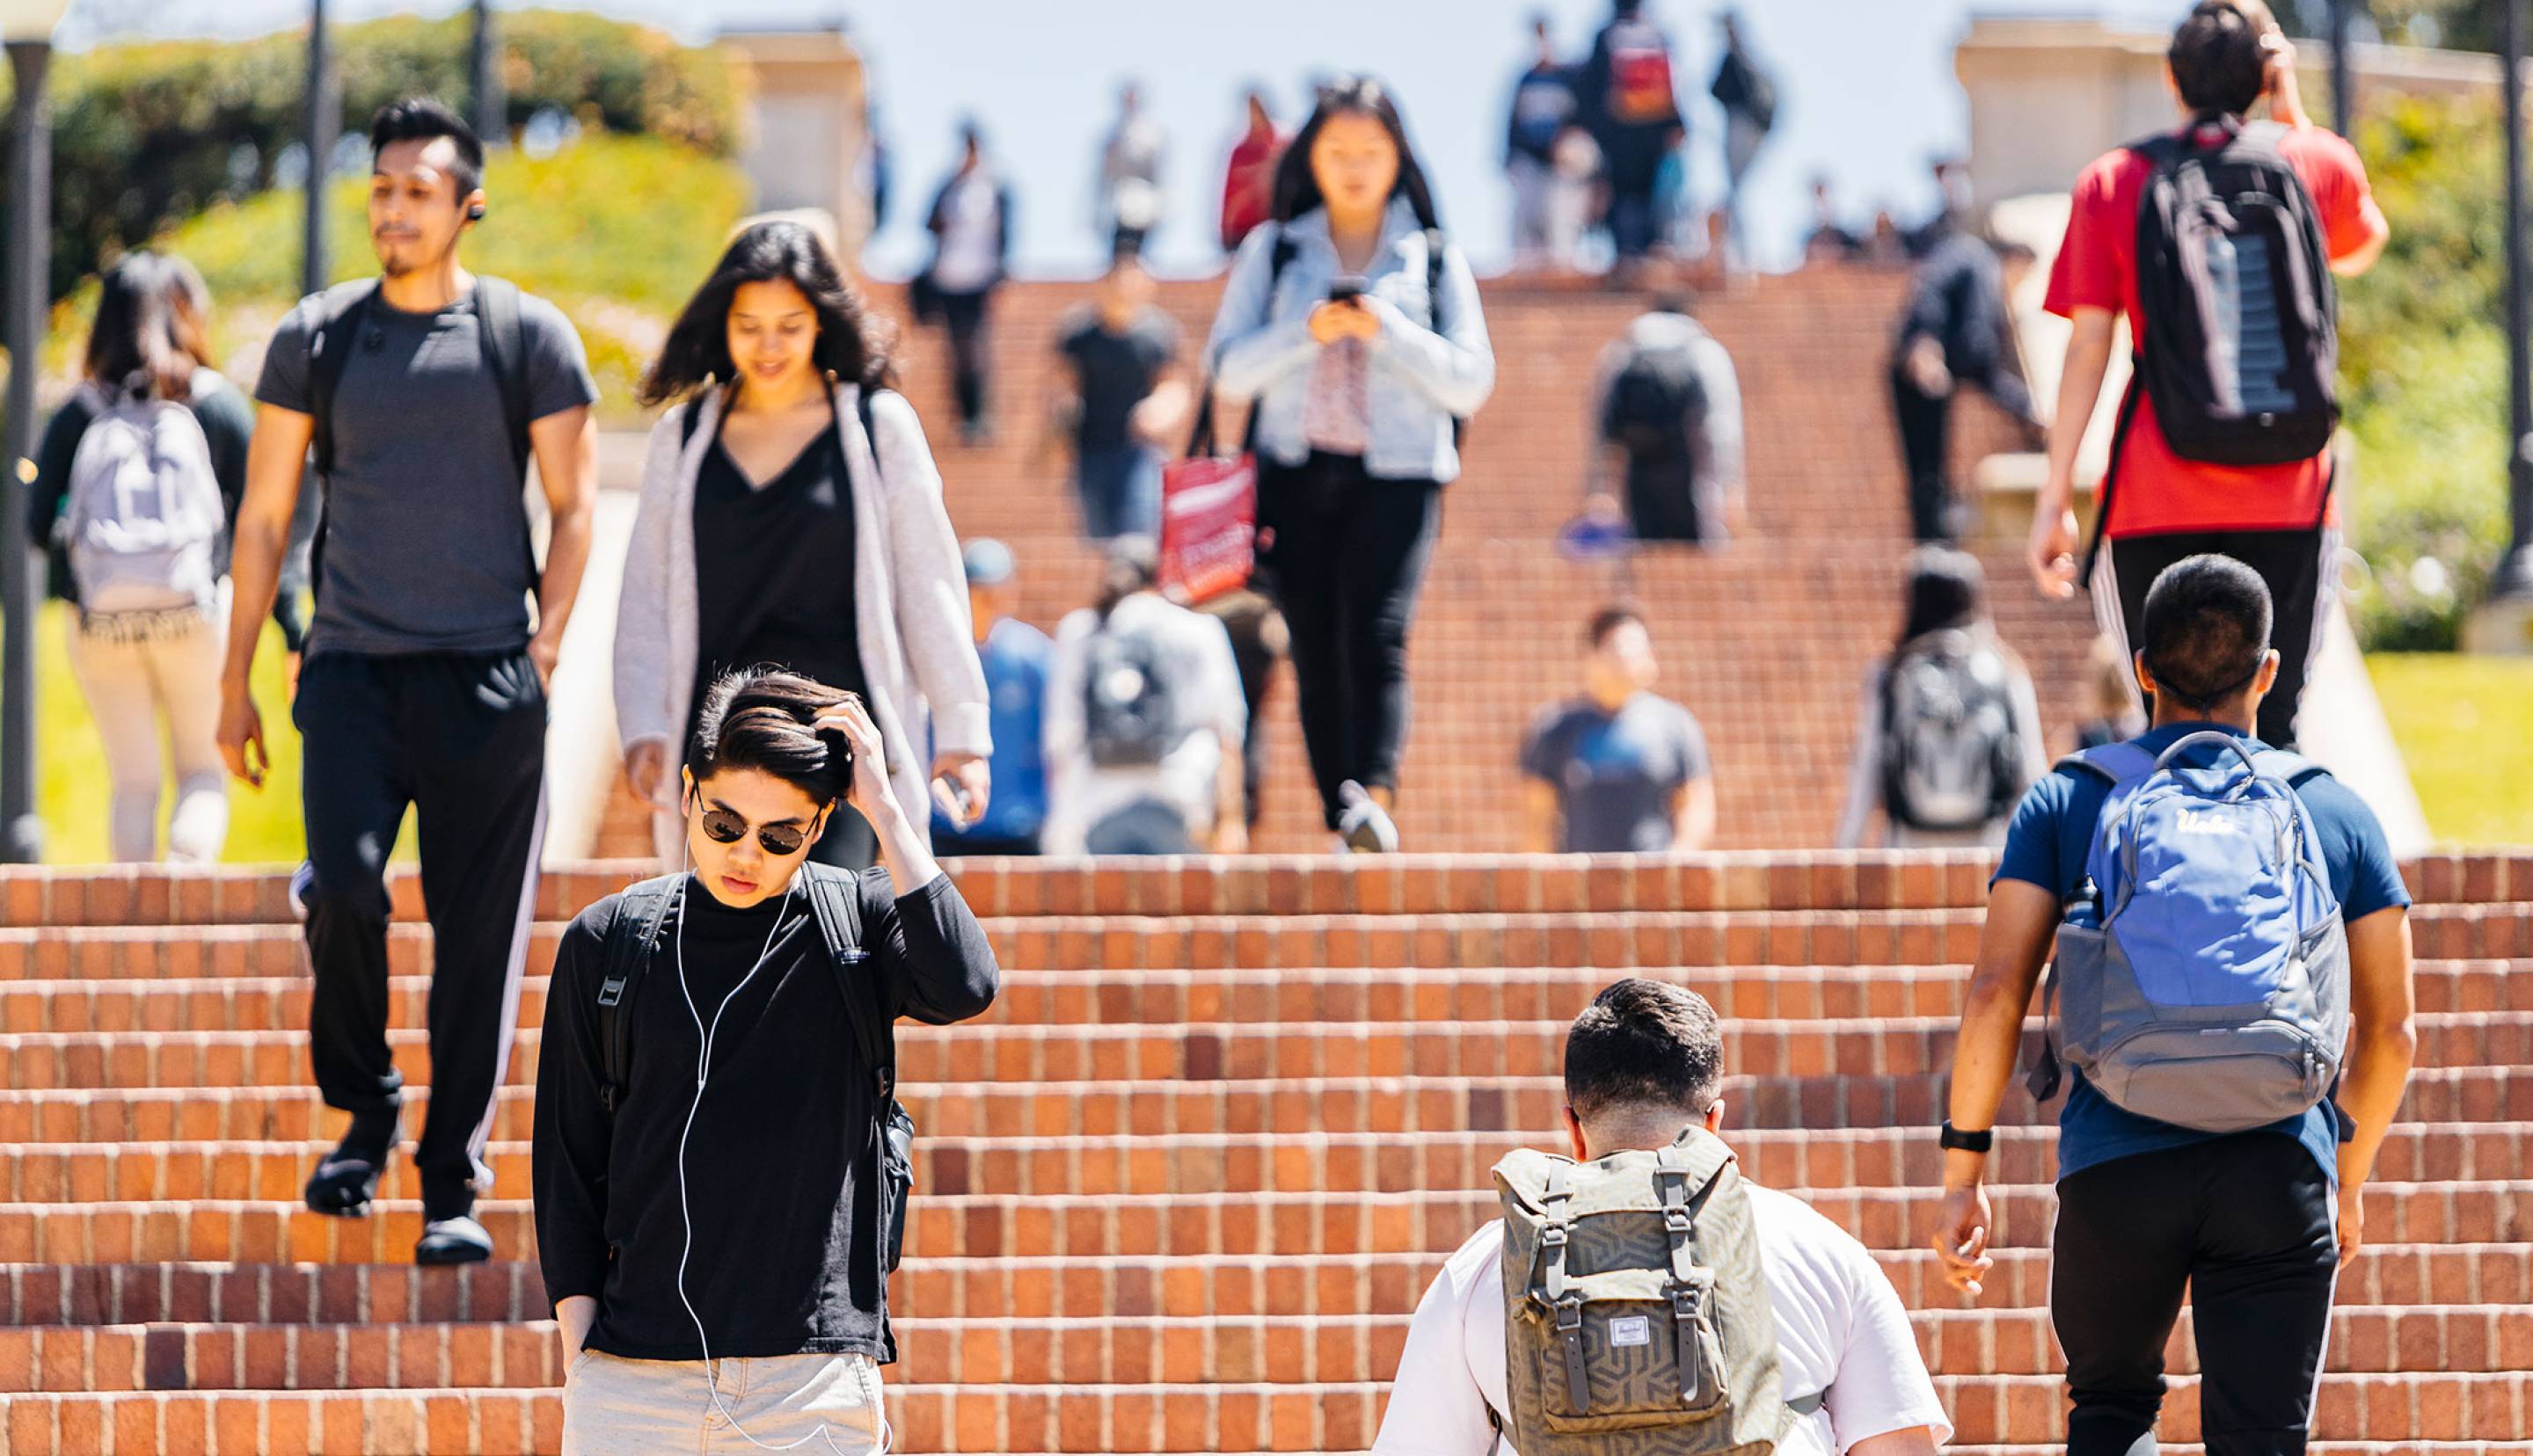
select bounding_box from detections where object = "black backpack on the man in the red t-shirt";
[2130,116,2340,466]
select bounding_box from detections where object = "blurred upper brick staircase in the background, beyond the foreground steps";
[601,268,2092,855]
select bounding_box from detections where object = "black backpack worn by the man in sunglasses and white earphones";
[598,863,915,1274]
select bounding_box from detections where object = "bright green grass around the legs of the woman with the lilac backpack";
[35,602,412,863]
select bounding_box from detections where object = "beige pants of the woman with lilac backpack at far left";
[71,594,228,863]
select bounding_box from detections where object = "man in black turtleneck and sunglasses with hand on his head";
[535,668,1001,1453]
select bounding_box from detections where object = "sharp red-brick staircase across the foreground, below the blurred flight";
[0,854,2533,1456]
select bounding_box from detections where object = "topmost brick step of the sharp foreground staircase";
[0,848,2533,927]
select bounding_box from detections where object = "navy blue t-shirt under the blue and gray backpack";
[1989,722,2409,1180]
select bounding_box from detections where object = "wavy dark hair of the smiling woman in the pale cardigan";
[639,218,897,405]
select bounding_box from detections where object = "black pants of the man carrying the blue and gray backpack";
[2049,1132,2338,1456]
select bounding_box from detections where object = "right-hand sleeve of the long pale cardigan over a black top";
[872,390,993,754]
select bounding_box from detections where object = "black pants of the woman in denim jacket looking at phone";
[1259,451,1442,828]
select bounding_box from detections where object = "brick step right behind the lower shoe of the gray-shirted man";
[0,1180,2533,1263]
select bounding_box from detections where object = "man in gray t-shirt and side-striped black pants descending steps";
[221,101,598,1263]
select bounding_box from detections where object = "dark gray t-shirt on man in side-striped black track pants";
[256,282,598,656]
